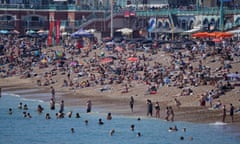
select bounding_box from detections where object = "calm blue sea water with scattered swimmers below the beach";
[0,93,240,144]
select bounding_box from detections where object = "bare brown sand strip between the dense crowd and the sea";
[0,77,240,128]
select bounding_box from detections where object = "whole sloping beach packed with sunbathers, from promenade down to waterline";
[0,29,240,123]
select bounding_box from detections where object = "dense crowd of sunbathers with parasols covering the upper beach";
[0,30,240,120]
